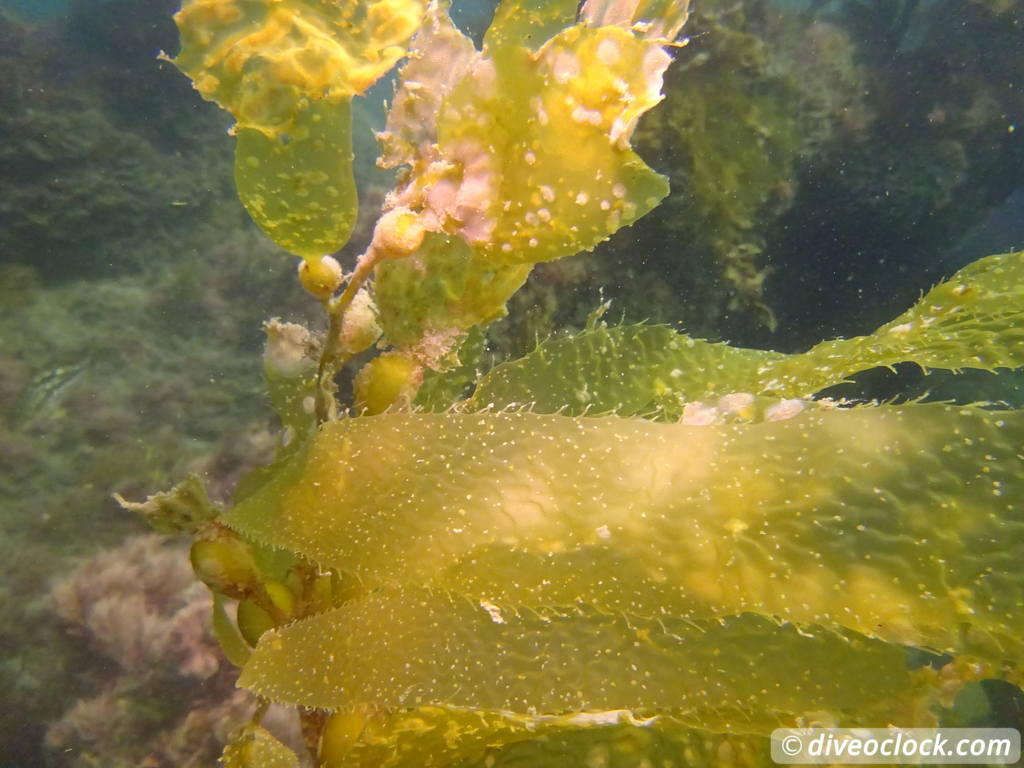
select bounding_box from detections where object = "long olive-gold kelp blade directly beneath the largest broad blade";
[239,588,927,733]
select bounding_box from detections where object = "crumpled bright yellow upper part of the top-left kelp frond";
[174,0,425,137]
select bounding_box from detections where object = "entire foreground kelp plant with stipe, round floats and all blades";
[124,0,1024,768]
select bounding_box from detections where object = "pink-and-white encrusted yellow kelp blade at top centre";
[381,2,671,266]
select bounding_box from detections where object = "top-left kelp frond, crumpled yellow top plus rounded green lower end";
[174,0,424,258]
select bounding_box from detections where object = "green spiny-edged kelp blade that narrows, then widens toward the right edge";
[463,252,1024,419]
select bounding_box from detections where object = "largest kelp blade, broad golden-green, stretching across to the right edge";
[223,404,1024,660]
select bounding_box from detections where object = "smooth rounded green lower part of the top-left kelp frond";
[234,100,358,257]
